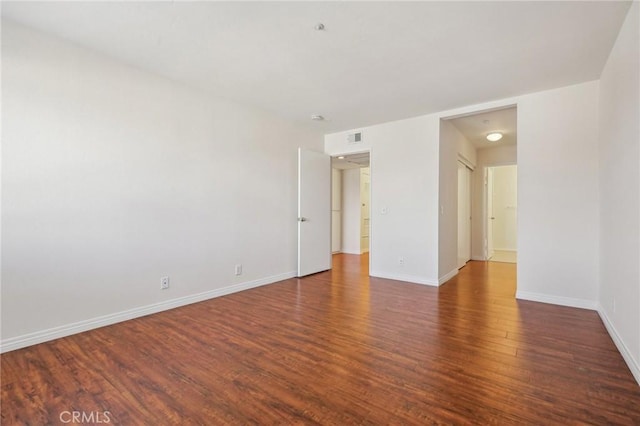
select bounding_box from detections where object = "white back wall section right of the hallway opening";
[517,82,598,308]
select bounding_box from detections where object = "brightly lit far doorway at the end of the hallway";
[486,165,518,263]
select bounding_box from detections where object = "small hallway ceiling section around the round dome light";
[449,107,518,149]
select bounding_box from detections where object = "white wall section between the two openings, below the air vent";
[325,115,440,285]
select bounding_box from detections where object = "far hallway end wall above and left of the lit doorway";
[471,145,518,260]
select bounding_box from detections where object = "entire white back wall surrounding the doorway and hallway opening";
[325,82,598,302]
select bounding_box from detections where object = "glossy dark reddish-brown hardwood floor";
[0,255,640,425]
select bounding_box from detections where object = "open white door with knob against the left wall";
[298,148,331,277]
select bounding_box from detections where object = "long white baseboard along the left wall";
[0,271,296,353]
